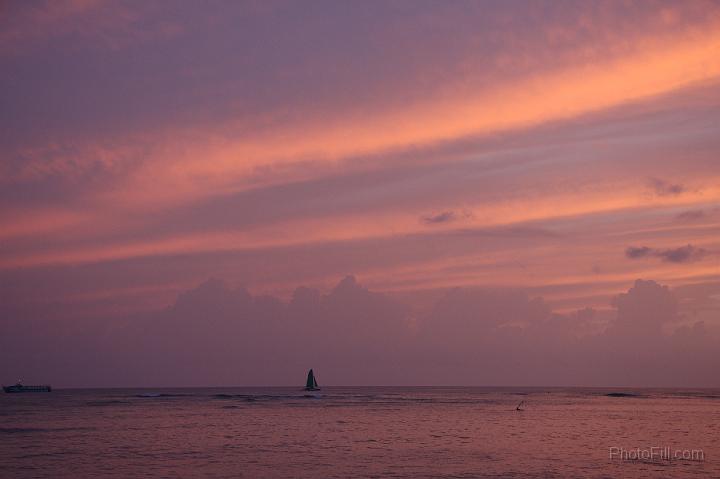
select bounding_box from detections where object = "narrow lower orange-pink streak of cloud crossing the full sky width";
[5,179,720,268]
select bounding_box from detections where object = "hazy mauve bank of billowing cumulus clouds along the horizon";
[0,276,718,387]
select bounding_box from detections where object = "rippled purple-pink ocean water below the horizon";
[0,387,720,478]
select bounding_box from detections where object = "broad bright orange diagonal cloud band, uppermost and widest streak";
[93,23,720,208]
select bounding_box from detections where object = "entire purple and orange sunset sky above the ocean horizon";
[0,0,720,387]
